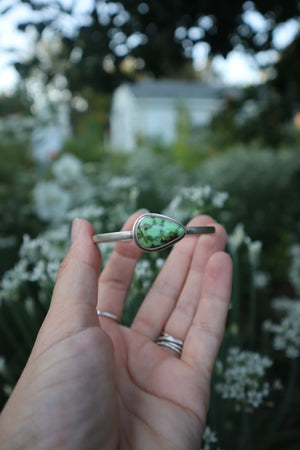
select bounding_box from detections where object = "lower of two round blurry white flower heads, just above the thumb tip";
[33,181,71,222]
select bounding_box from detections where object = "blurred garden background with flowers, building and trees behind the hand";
[0,0,300,450]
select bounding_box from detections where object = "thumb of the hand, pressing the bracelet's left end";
[35,219,101,345]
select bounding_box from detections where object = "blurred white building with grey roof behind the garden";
[110,80,236,151]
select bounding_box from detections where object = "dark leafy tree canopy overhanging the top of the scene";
[4,0,300,90]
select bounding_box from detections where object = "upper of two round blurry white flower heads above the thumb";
[52,154,82,186]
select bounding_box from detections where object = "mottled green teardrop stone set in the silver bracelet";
[136,215,185,250]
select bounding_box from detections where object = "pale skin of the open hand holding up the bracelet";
[0,213,232,450]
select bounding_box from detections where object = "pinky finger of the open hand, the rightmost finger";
[182,252,232,380]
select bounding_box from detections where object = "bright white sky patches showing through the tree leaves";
[0,0,299,93]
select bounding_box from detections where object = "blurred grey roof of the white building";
[128,80,229,99]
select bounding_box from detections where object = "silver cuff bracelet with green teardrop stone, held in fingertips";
[93,213,216,252]
